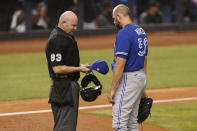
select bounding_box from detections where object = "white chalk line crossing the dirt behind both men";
[0,97,197,116]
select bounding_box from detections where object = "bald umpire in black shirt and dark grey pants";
[46,11,90,131]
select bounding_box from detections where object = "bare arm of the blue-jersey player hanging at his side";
[108,57,126,103]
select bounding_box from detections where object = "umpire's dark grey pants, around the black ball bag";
[51,81,80,131]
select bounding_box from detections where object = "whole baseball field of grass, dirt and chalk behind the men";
[0,31,197,131]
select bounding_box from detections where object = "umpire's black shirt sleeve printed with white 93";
[48,35,72,66]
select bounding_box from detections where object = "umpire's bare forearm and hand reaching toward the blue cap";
[52,65,90,74]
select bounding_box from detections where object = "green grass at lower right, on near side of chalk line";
[89,102,197,131]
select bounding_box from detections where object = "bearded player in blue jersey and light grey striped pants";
[108,4,148,131]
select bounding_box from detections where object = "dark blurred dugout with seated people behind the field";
[0,0,197,39]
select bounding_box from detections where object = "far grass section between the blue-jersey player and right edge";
[148,45,197,89]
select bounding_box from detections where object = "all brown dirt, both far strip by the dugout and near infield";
[0,31,197,131]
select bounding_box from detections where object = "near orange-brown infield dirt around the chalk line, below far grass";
[0,87,197,131]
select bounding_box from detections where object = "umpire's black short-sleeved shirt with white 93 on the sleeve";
[45,27,80,81]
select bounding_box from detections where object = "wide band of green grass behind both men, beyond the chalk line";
[0,45,197,100]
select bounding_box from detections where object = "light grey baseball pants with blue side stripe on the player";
[112,69,147,131]
